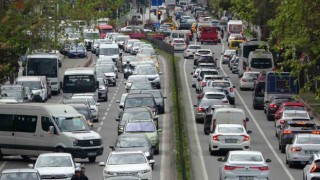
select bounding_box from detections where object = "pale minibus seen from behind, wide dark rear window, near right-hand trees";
[247,49,274,72]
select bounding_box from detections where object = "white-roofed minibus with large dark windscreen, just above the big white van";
[62,67,99,99]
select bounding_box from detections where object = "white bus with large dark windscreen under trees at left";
[24,51,63,94]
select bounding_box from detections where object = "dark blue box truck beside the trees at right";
[264,72,299,102]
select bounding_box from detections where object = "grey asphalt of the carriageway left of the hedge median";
[0,50,175,180]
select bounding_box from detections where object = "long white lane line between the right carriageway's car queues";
[220,41,294,180]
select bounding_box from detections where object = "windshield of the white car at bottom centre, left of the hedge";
[107,153,147,165]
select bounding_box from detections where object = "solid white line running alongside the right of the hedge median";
[183,59,209,180]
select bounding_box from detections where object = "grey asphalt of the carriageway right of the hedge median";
[175,10,303,180]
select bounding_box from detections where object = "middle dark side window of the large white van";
[14,115,37,133]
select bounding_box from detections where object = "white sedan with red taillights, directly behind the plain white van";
[209,124,251,155]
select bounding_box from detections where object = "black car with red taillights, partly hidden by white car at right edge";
[279,120,319,153]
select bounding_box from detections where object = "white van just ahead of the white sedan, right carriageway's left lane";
[210,107,249,131]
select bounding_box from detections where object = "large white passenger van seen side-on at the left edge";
[0,103,103,162]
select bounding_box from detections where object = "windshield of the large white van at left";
[54,116,90,132]
